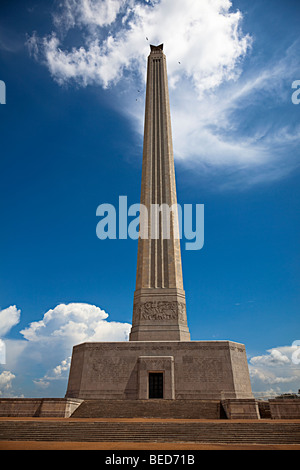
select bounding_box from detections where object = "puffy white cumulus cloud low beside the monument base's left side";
[0,302,131,396]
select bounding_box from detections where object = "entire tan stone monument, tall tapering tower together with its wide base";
[66,45,257,418]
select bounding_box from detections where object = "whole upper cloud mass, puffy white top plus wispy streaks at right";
[28,0,300,187]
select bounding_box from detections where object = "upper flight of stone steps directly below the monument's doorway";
[72,399,226,419]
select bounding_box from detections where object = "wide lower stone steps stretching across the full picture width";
[0,418,300,444]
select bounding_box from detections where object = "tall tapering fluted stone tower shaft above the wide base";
[130,44,190,341]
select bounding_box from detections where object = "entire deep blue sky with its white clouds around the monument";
[0,0,300,396]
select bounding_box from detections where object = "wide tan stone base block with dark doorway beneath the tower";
[66,341,253,400]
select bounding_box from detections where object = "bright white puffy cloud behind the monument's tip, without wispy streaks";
[29,0,251,93]
